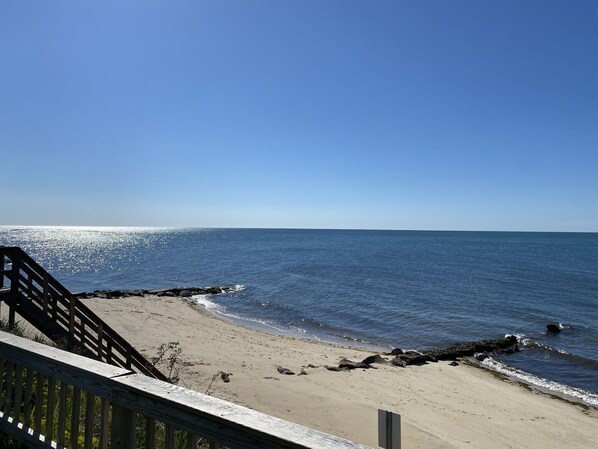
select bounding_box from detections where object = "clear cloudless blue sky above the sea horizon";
[0,0,598,232]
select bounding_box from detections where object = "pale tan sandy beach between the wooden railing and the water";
[83,296,598,449]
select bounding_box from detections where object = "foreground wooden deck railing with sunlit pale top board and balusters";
[0,332,376,449]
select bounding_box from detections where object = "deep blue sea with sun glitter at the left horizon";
[0,226,598,405]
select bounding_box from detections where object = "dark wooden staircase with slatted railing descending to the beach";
[0,246,168,381]
